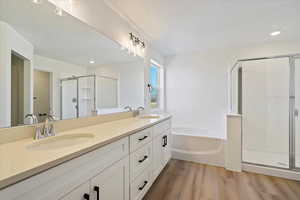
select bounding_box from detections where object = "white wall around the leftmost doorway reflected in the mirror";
[0,21,34,127]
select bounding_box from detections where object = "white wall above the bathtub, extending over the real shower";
[165,42,300,138]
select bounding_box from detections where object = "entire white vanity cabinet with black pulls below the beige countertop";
[0,119,171,200]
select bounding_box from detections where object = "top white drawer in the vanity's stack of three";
[130,128,152,152]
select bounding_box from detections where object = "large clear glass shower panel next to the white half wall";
[239,58,290,168]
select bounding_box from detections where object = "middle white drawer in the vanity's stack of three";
[130,142,153,181]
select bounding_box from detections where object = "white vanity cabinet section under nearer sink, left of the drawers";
[0,137,129,200]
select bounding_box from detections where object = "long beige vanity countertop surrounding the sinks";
[0,114,171,189]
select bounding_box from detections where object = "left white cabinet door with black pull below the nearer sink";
[60,182,90,200]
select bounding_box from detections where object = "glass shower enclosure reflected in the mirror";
[60,75,96,119]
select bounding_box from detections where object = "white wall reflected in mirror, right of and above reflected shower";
[89,61,145,108]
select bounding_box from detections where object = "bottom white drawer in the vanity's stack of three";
[130,167,152,200]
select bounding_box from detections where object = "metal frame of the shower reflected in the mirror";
[60,74,97,119]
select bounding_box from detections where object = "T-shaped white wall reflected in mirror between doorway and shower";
[34,55,87,117]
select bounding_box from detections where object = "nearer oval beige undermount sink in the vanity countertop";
[27,133,94,150]
